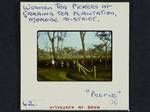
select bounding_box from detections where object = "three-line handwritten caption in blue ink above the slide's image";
[22,2,117,23]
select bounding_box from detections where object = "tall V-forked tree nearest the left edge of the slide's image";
[47,31,57,60]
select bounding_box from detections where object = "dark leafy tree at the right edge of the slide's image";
[96,31,112,69]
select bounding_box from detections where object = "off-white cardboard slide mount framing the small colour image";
[20,2,129,110]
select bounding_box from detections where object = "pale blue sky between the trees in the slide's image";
[38,32,110,50]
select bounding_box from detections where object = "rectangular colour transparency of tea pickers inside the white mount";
[37,30,112,81]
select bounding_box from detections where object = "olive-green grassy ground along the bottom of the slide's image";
[37,65,112,81]
